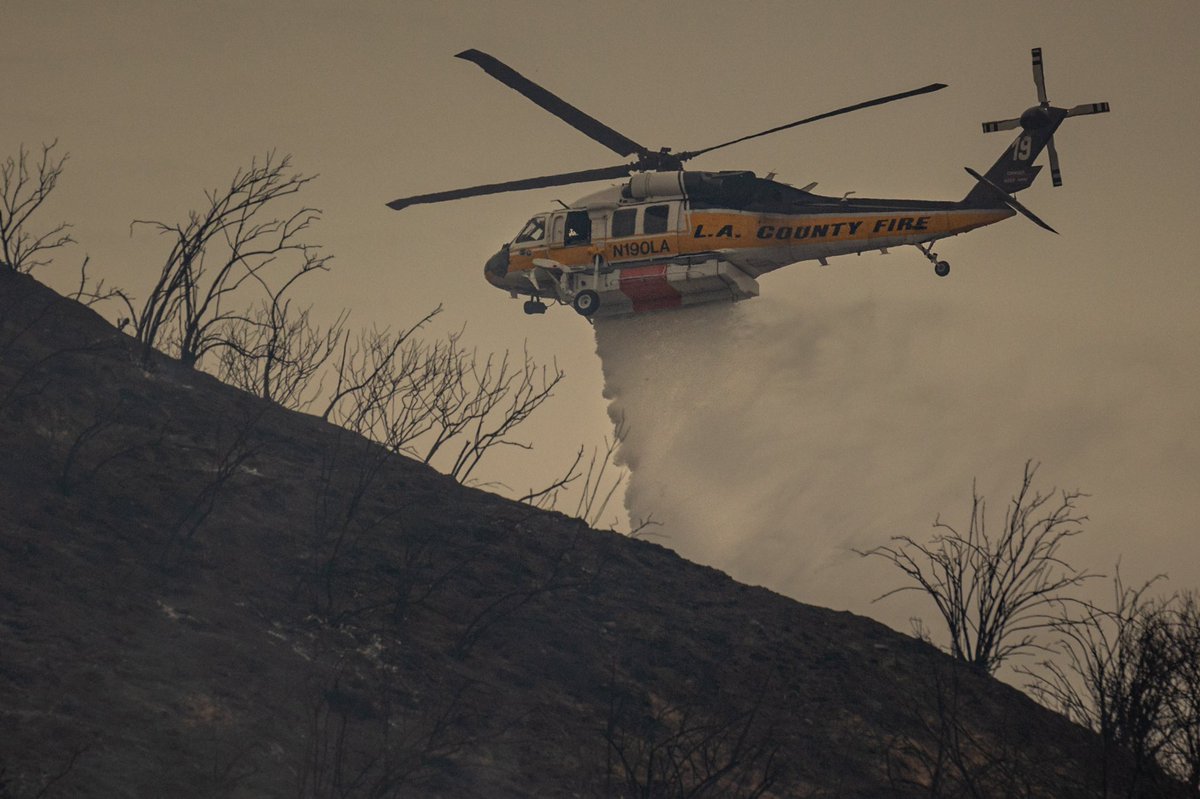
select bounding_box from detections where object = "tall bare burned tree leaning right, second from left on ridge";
[125,152,329,367]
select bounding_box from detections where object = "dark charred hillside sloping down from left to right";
[0,268,1174,798]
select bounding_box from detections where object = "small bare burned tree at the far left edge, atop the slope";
[0,140,74,275]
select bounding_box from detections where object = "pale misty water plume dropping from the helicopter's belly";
[595,274,1195,629]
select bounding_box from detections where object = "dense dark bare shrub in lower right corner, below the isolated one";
[1025,571,1178,797]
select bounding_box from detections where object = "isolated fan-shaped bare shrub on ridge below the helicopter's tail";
[859,461,1094,674]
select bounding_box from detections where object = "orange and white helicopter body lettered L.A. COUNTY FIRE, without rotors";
[485,172,1013,294]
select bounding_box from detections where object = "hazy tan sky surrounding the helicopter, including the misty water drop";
[9,0,1200,643]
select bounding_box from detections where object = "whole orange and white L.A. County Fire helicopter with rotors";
[388,48,1109,318]
